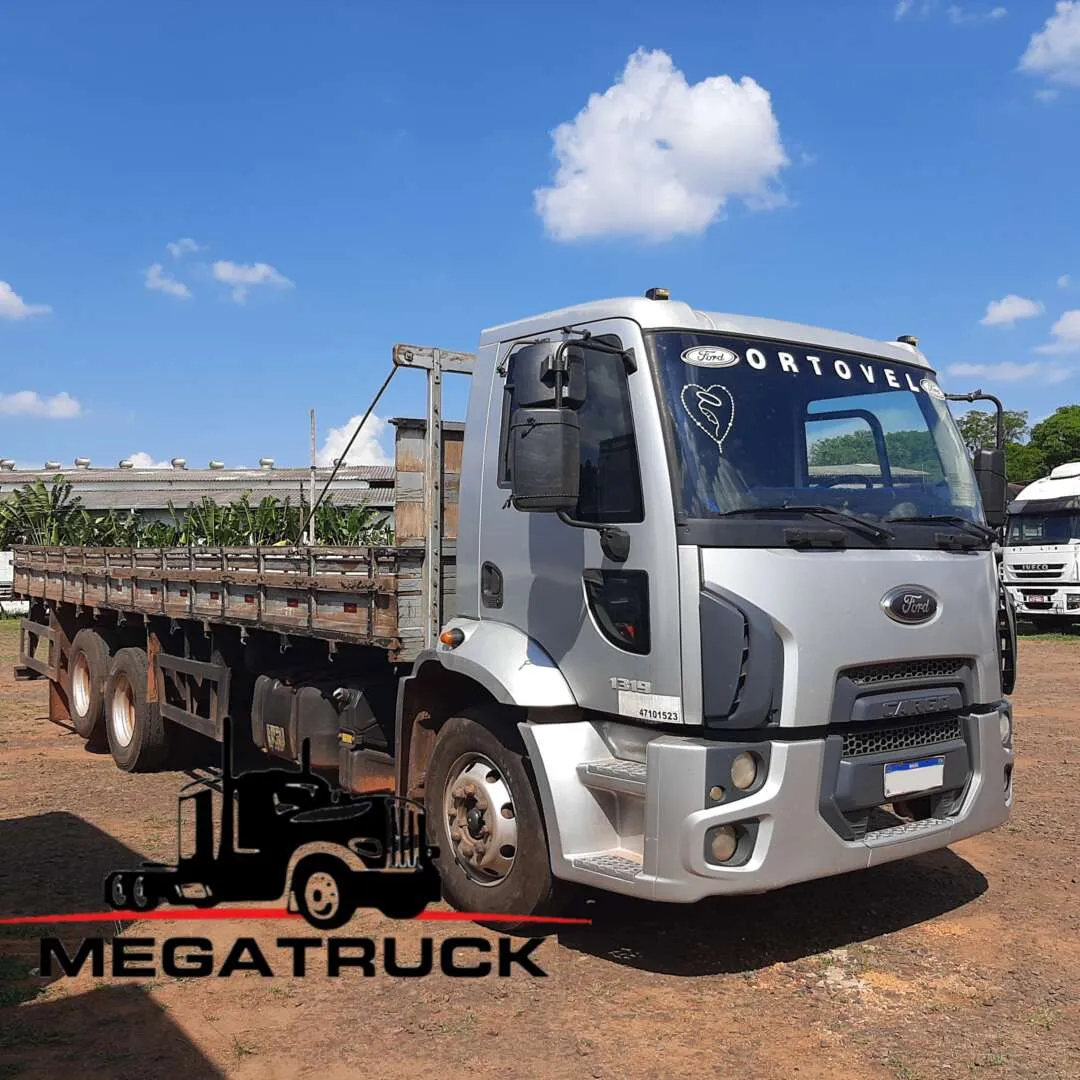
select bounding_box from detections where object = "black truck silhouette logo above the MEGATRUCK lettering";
[105,719,442,930]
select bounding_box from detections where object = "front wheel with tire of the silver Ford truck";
[424,708,565,933]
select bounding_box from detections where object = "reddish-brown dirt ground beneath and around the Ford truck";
[0,620,1080,1080]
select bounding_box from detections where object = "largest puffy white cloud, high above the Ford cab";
[534,50,788,241]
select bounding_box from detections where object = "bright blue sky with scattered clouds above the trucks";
[0,0,1080,465]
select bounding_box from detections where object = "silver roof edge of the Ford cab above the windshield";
[480,297,930,369]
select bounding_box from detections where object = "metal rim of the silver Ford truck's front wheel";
[443,754,517,886]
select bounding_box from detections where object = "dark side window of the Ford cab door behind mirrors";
[499,339,645,525]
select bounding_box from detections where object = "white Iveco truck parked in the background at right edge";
[1002,461,1080,631]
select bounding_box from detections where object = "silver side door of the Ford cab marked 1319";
[480,320,684,724]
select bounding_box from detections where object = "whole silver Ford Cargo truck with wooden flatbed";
[15,289,1016,914]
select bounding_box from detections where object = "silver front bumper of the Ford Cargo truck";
[521,702,1013,903]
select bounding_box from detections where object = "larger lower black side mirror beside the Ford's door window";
[509,408,581,512]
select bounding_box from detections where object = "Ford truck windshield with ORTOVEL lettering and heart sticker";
[649,330,983,531]
